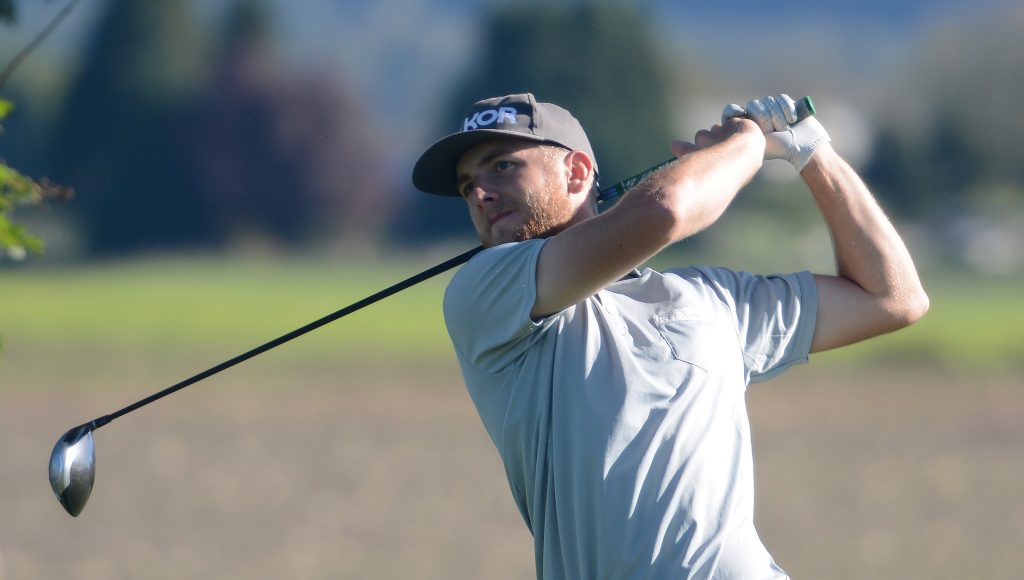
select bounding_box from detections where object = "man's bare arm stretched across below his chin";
[530,119,765,319]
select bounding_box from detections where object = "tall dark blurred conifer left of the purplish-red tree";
[53,0,209,254]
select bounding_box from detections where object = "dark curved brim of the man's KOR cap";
[413,129,548,197]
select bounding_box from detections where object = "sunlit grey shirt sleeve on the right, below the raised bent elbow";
[699,267,818,382]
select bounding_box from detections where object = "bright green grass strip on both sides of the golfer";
[0,256,1024,372]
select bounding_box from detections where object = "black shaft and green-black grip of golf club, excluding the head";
[79,96,815,430]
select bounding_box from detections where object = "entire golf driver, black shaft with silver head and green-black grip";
[49,96,814,516]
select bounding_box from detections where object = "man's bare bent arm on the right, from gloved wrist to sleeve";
[801,143,929,351]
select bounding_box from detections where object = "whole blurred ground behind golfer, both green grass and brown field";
[0,256,1024,580]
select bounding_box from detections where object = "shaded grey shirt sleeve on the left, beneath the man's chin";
[444,240,557,373]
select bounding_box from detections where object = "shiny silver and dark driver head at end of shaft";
[50,424,96,516]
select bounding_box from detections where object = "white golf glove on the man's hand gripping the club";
[722,94,831,173]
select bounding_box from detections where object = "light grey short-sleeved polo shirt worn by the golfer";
[444,240,817,580]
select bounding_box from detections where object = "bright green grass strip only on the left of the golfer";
[0,255,452,366]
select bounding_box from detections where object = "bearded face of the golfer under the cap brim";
[456,139,572,247]
